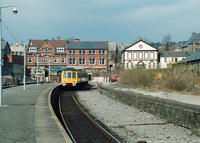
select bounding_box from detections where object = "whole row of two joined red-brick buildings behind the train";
[27,37,108,81]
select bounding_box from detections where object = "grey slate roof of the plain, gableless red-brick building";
[67,41,108,50]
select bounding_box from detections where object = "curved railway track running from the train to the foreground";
[59,91,121,143]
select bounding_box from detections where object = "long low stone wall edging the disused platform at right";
[98,84,200,130]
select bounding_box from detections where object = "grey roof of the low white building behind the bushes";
[160,51,188,57]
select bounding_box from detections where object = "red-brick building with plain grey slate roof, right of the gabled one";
[67,39,108,72]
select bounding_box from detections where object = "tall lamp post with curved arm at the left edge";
[0,5,18,106]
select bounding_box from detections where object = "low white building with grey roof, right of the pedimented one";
[160,51,188,68]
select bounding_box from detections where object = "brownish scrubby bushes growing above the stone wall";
[119,65,196,92]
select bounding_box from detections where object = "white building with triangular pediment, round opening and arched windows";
[122,39,158,69]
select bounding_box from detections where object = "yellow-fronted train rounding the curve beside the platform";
[61,68,89,87]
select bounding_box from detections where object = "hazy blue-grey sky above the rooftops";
[0,0,200,44]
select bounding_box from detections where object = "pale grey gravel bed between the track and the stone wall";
[77,86,200,143]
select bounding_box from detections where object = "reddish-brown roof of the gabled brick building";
[29,40,67,47]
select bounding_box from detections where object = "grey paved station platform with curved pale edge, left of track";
[0,83,71,143]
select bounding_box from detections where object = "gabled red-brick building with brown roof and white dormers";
[27,37,67,81]
